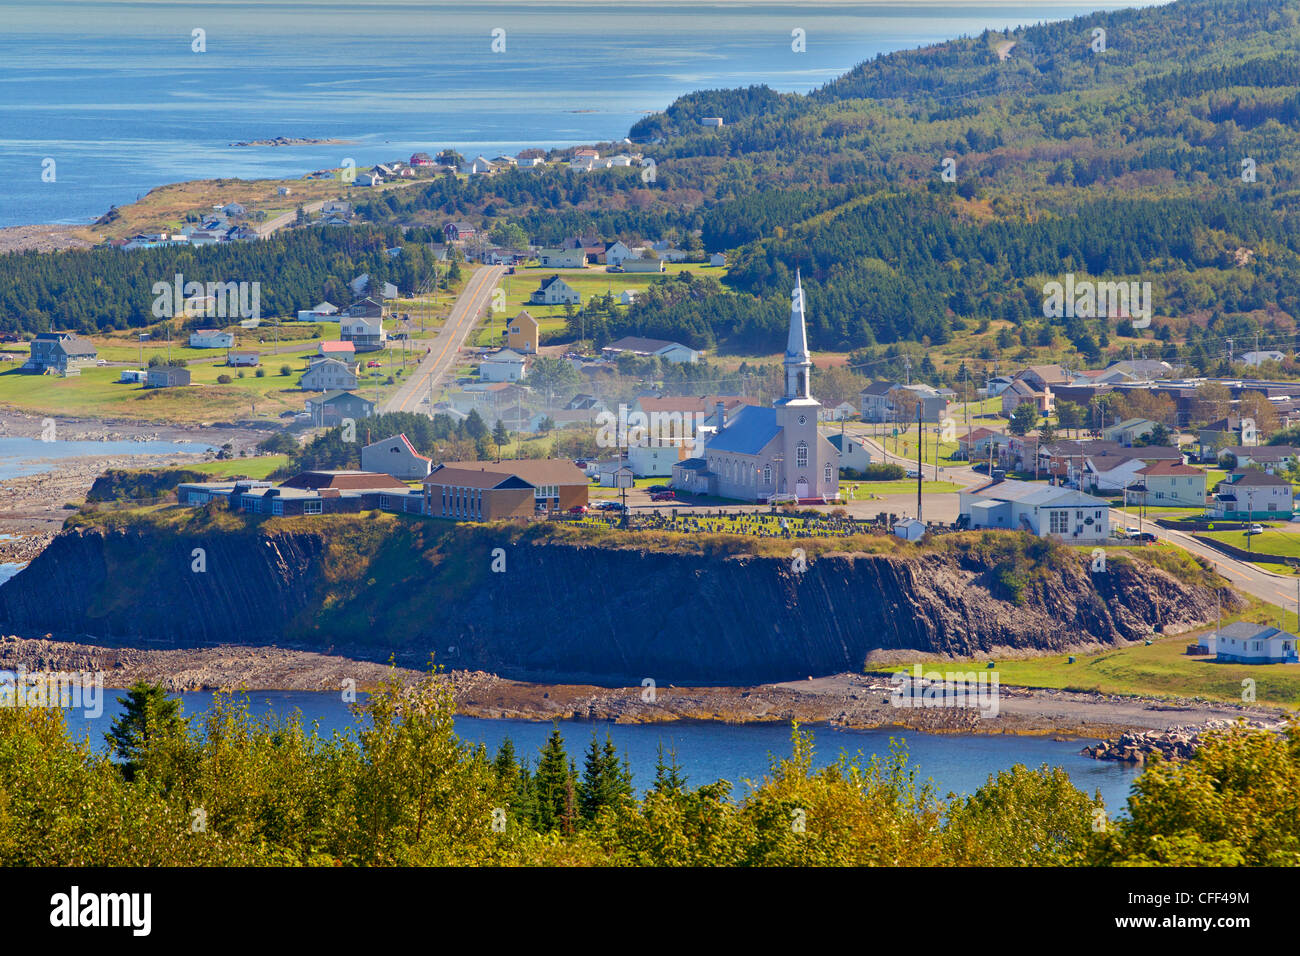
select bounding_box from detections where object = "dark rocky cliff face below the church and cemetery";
[0,522,1235,685]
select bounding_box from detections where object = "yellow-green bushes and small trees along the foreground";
[0,675,1300,866]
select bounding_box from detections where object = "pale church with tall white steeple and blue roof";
[672,274,840,505]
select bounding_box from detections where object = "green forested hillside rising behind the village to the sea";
[0,0,1300,372]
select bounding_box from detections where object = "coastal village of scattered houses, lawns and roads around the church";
[0,130,1300,733]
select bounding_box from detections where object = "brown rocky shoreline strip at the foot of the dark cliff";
[0,635,1284,740]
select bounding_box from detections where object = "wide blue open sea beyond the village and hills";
[0,0,1134,226]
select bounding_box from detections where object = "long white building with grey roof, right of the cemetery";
[959,480,1110,545]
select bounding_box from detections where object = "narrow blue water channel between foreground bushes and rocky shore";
[58,691,1138,813]
